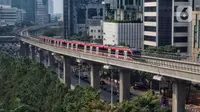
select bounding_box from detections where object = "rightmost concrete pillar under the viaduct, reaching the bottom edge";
[172,80,187,112]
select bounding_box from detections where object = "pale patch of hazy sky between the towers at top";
[53,0,63,13]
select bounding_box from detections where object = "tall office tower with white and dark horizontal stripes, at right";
[144,0,192,52]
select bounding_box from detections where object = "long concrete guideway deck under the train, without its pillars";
[21,36,200,82]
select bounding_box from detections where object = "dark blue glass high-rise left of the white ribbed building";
[63,0,103,37]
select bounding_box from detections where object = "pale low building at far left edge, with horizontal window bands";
[0,5,26,26]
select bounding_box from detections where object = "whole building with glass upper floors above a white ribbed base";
[103,0,143,49]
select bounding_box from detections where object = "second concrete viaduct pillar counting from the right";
[119,69,131,102]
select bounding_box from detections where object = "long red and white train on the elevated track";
[39,36,141,60]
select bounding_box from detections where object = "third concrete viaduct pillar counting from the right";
[90,63,102,90]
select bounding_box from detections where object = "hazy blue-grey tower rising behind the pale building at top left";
[11,0,37,22]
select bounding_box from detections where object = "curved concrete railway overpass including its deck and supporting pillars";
[18,24,200,112]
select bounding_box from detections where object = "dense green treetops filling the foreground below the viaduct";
[0,53,170,112]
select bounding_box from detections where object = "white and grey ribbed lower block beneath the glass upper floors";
[103,22,143,49]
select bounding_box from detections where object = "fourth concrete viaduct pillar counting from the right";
[63,56,72,89]
